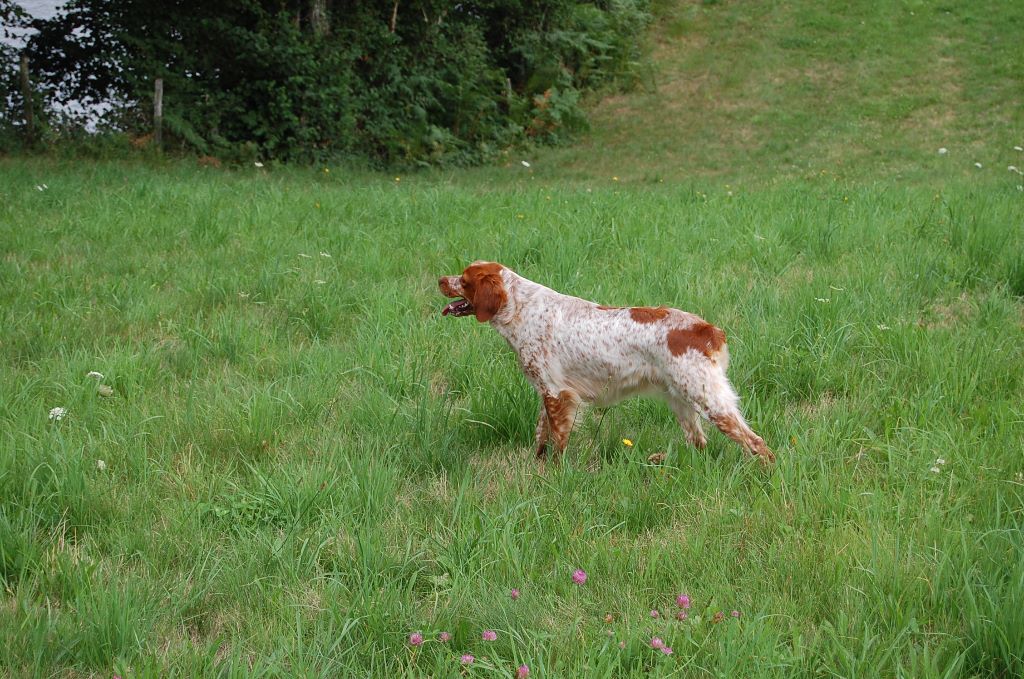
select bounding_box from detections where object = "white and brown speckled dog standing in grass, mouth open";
[438,262,775,463]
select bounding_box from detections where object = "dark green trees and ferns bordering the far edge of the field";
[0,0,648,165]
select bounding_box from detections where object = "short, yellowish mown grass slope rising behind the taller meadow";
[538,0,1024,184]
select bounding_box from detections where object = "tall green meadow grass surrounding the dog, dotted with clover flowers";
[0,3,1024,678]
